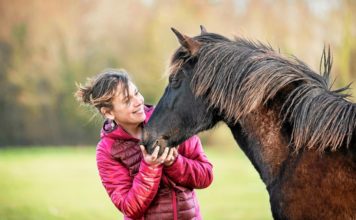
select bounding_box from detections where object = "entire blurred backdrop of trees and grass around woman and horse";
[0,0,356,219]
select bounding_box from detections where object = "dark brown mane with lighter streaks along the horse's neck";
[182,35,356,151]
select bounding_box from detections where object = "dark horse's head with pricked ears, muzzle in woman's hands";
[143,26,227,153]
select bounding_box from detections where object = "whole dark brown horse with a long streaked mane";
[143,26,356,219]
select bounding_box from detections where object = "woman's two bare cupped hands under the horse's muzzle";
[140,145,178,166]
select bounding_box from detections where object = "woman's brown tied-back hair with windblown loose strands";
[75,69,130,112]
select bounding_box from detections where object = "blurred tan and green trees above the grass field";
[0,0,356,146]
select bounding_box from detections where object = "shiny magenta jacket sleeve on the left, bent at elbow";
[96,142,162,218]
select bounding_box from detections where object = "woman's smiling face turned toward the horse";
[111,82,146,127]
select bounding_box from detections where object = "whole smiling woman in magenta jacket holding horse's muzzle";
[76,70,213,220]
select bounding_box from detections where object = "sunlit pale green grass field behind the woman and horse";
[0,147,272,220]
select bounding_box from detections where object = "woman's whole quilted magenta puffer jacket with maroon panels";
[96,107,213,219]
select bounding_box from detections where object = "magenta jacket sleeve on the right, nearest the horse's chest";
[164,136,213,189]
